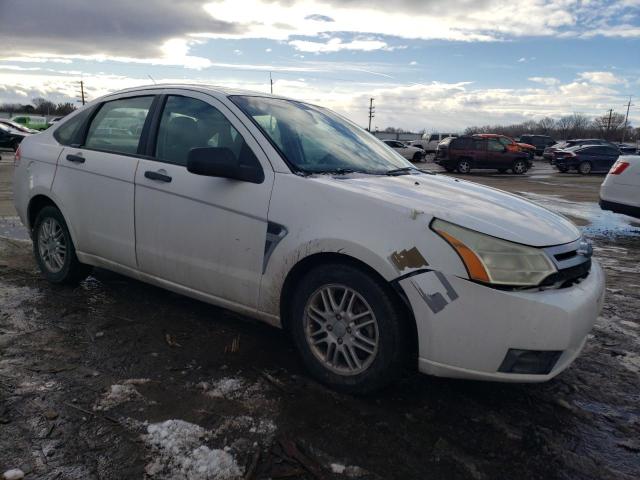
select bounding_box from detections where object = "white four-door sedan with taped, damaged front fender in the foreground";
[14,85,604,392]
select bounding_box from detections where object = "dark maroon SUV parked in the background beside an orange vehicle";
[434,136,532,174]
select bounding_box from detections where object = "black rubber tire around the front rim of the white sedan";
[289,263,411,394]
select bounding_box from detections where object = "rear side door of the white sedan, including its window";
[53,92,154,268]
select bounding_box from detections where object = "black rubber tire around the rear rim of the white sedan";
[33,206,92,285]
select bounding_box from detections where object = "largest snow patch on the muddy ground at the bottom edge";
[143,420,242,480]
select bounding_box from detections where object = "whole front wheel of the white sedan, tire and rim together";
[289,263,411,394]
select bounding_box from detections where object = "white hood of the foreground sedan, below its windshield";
[315,174,580,247]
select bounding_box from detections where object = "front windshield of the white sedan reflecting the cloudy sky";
[230,96,415,174]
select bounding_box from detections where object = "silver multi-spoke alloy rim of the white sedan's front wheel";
[304,284,380,376]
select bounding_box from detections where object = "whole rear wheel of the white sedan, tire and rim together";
[33,206,91,285]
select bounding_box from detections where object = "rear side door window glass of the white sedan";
[84,95,153,154]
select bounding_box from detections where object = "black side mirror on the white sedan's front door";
[187,147,264,183]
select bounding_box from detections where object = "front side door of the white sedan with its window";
[135,90,274,308]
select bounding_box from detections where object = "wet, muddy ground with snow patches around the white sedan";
[0,155,640,480]
